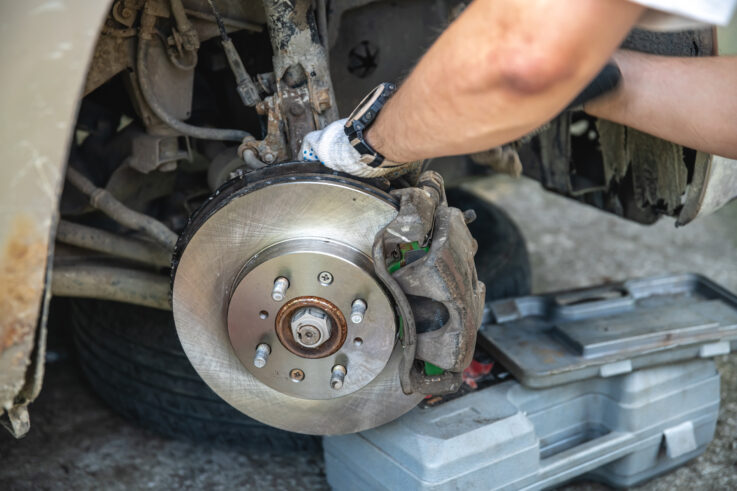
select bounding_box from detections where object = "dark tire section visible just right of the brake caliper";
[446,188,531,303]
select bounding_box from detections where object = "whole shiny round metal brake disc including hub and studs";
[172,163,422,435]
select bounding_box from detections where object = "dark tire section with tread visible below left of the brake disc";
[70,299,321,452]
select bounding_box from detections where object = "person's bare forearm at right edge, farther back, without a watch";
[584,51,737,159]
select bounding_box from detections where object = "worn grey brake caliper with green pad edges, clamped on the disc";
[374,171,486,394]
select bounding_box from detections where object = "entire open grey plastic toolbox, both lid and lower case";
[324,275,737,491]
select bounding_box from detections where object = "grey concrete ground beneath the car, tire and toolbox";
[0,178,737,490]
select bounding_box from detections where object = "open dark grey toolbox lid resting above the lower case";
[479,274,737,387]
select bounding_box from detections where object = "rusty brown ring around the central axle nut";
[275,296,348,359]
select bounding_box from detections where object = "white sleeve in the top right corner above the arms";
[629,0,737,31]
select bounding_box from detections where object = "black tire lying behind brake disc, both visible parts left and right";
[69,189,530,451]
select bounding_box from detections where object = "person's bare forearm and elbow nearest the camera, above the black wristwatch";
[366,0,643,162]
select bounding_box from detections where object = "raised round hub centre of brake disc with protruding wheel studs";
[228,238,396,400]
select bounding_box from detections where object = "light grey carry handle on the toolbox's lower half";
[539,431,636,482]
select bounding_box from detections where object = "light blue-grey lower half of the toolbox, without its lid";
[323,360,719,491]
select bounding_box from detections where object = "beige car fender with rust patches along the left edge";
[0,0,110,437]
